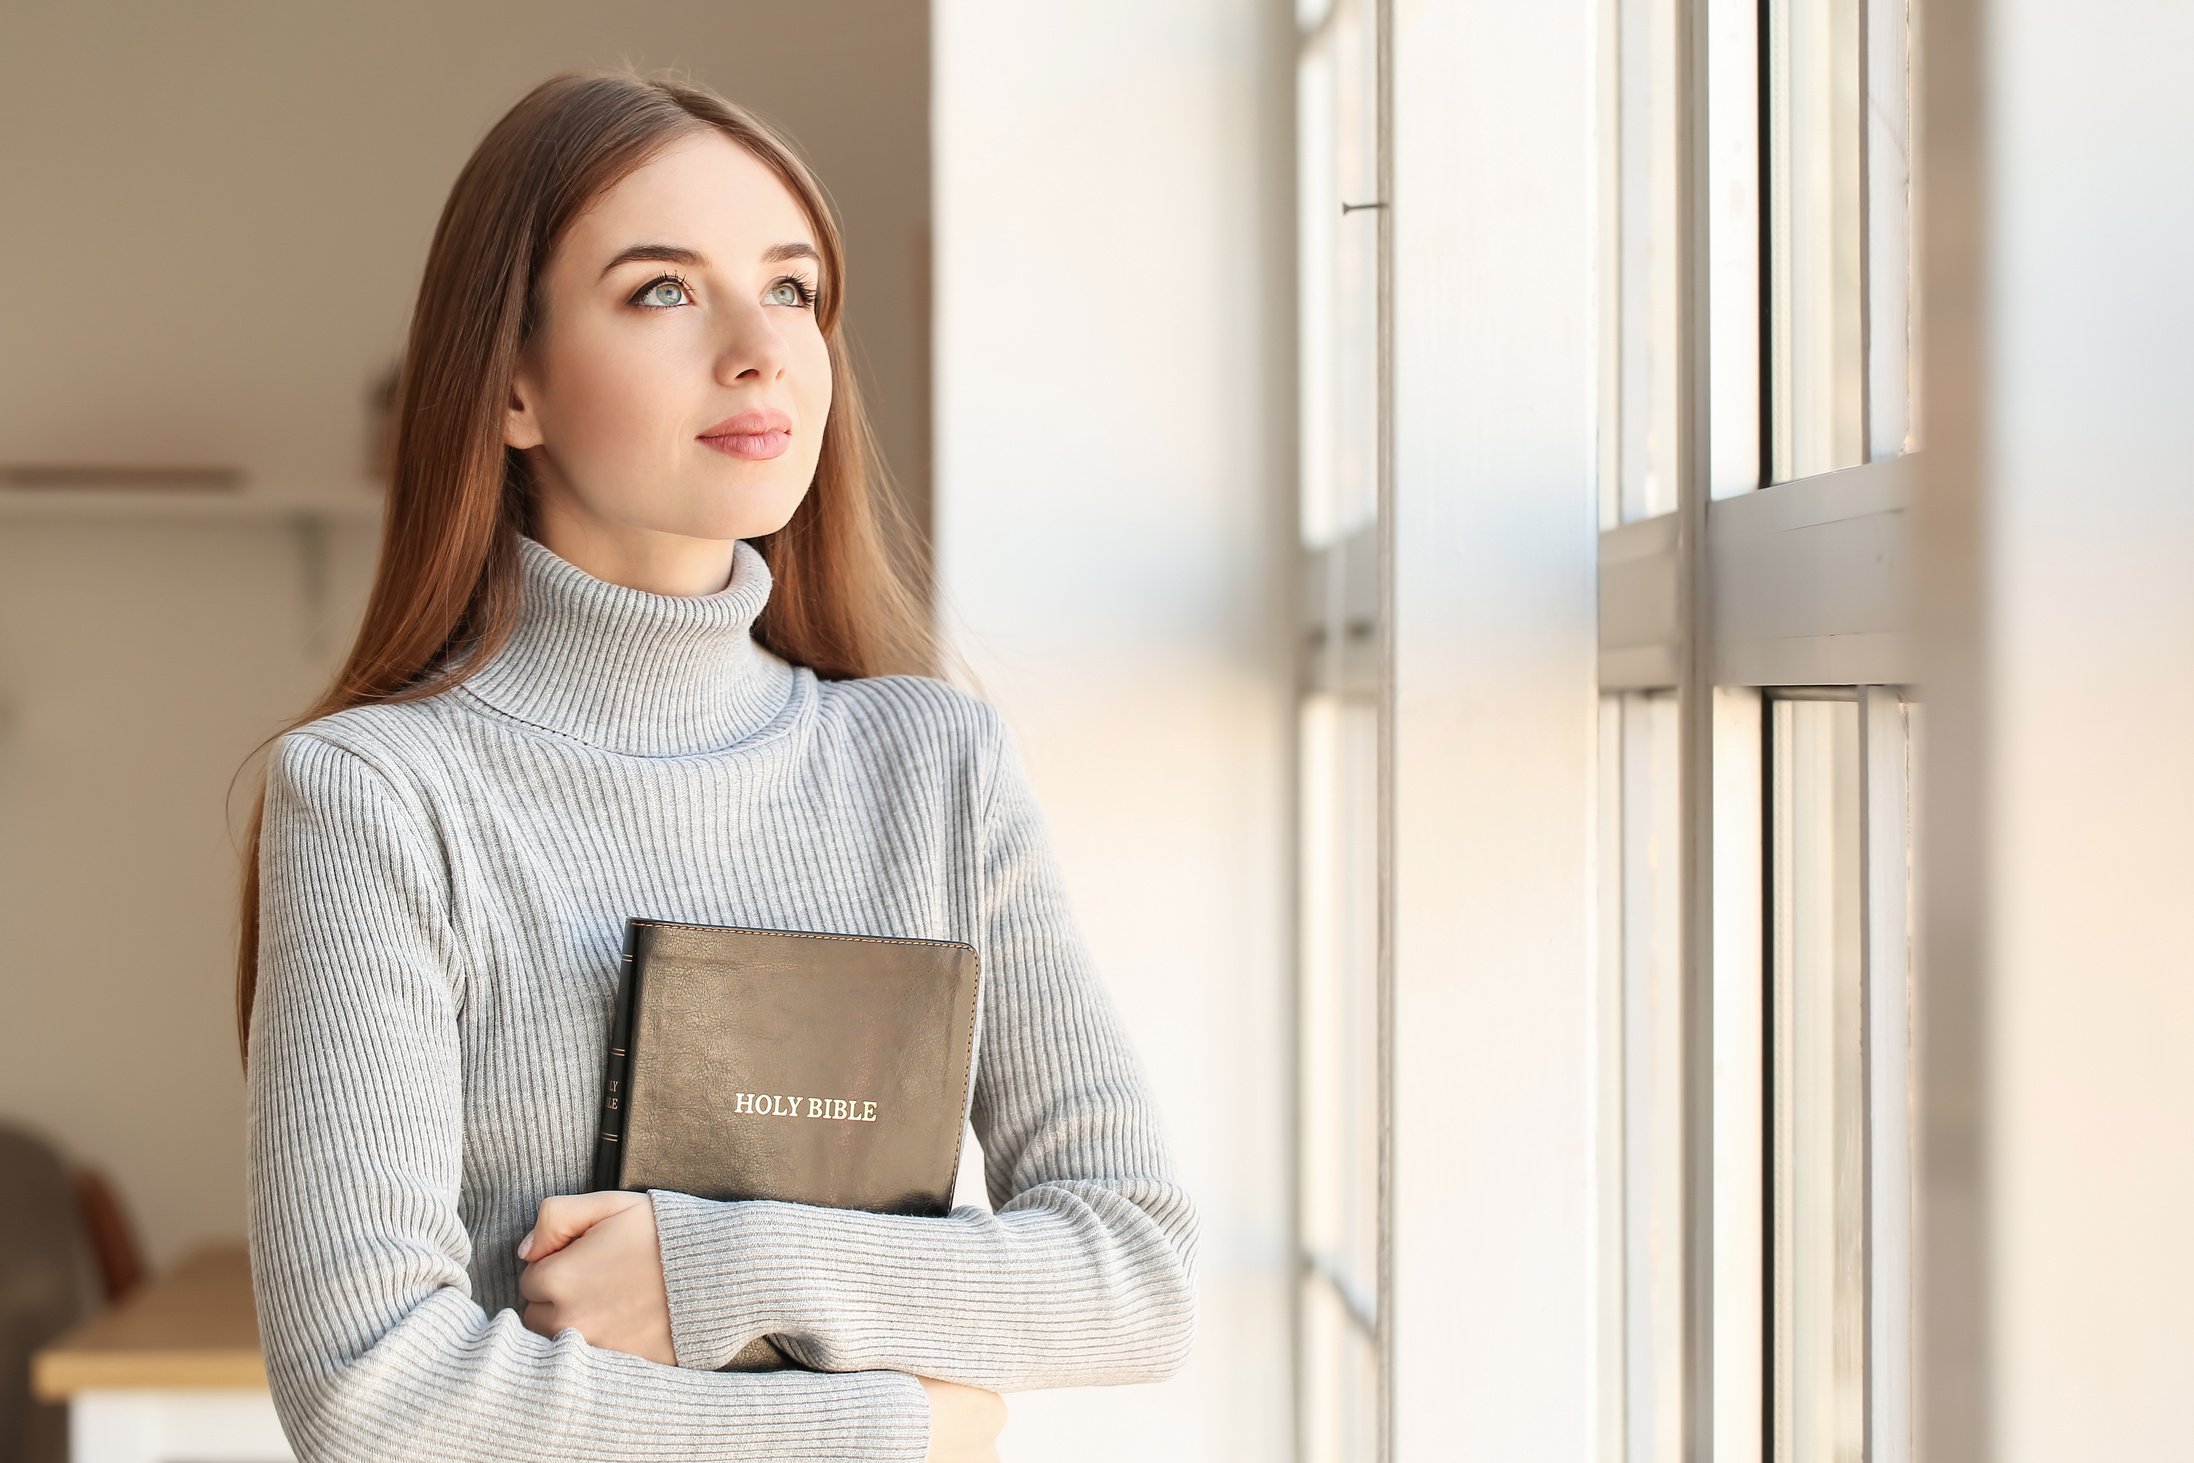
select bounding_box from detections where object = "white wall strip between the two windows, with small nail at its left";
[1391,0,1606,1463]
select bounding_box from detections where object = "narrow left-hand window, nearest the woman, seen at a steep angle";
[1292,0,1387,1463]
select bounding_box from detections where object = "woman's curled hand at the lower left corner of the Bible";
[518,1189,678,1366]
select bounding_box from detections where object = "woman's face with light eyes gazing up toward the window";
[505,132,836,570]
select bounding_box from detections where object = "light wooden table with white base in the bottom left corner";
[31,1241,294,1463]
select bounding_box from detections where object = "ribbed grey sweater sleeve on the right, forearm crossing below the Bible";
[649,704,1198,1391]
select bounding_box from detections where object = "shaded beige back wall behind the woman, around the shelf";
[0,0,930,1266]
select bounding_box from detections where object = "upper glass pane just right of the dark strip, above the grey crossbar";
[1766,0,1867,483]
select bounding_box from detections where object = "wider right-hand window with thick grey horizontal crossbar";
[1599,0,1920,1463]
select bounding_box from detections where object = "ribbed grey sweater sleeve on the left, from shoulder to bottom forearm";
[246,730,928,1463]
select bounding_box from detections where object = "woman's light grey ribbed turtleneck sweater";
[248,537,1196,1463]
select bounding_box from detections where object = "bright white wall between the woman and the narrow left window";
[932,0,1294,1463]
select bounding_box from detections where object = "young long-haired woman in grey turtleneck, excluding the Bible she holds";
[237,72,1196,1463]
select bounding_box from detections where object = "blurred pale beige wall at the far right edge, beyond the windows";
[1913,0,2194,1463]
